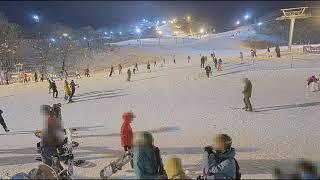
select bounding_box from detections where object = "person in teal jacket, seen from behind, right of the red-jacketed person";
[133,131,166,179]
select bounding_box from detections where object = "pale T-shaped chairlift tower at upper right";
[276,7,311,51]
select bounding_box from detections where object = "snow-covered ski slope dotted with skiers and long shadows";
[0,26,320,178]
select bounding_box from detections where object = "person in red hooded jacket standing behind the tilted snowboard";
[120,111,135,151]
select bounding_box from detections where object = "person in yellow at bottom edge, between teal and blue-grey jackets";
[164,156,191,179]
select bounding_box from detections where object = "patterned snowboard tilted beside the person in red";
[100,151,133,179]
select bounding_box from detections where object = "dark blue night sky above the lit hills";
[0,1,320,29]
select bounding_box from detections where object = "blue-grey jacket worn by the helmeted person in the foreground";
[203,148,236,179]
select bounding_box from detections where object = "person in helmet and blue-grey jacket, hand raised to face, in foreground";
[203,134,239,179]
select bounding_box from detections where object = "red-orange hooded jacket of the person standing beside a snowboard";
[120,113,133,146]
